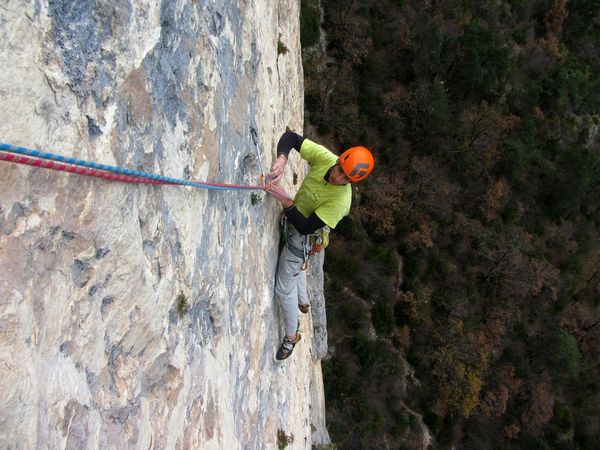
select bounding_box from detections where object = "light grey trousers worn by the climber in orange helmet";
[275,224,308,336]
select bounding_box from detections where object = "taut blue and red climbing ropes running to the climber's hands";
[0,142,270,190]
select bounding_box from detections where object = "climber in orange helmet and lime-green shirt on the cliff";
[265,131,375,360]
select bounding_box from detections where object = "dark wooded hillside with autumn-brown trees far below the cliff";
[301,0,600,450]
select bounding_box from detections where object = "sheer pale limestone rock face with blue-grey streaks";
[0,0,329,449]
